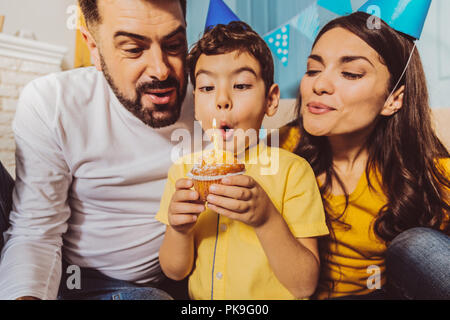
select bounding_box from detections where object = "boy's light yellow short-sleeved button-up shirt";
[156,143,328,300]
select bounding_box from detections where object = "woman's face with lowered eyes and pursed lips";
[300,28,390,137]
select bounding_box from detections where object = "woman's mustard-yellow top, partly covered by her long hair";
[280,126,450,299]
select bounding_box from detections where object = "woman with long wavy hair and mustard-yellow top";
[281,12,450,299]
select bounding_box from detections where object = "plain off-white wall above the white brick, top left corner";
[0,0,77,69]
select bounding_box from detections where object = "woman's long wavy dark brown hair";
[296,12,450,294]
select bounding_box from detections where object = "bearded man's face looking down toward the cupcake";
[94,0,187,128]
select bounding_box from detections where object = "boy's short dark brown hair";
[187,21,274,94]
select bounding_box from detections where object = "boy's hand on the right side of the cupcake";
[207,175,277,228]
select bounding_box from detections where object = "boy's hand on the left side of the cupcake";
[169,179,205,234]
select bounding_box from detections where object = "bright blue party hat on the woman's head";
[358,0,431,39]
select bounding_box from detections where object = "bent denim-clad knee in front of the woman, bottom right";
[386,228,450,300]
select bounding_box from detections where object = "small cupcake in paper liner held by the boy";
[188,150,245,202]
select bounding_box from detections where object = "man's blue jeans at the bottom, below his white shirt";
[58,261,187,300]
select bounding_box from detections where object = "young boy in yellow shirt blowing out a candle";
[157,22,328,299]
